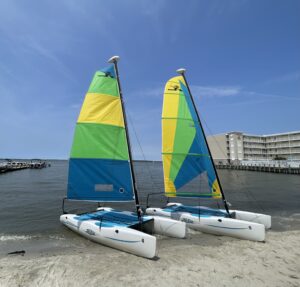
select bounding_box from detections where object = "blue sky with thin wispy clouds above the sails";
[0,0,300,160]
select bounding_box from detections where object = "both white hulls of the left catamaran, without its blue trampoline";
[60,208,186,258]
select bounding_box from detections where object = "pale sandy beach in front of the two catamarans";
[0,230,300,287]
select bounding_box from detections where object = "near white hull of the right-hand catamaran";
[146,205,265,241]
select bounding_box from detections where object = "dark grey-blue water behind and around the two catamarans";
[0,160,300,252]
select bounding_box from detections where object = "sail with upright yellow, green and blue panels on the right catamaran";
[162,76,221,198]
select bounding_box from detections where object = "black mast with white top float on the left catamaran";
[108,56,142,220]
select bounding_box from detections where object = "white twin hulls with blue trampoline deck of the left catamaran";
[60,207,187,258]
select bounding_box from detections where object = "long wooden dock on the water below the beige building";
[216,164,300,174]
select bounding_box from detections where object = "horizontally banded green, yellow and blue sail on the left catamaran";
[67,65,134,202]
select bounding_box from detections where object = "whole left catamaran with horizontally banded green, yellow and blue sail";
[60,56,186,258]
